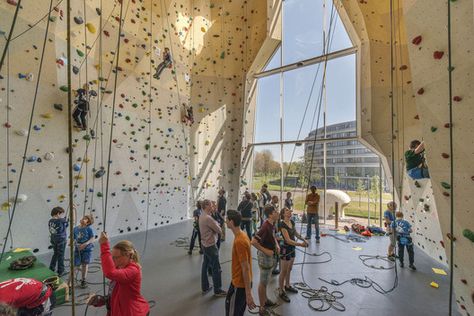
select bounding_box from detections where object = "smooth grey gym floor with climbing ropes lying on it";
[45,221,458,316]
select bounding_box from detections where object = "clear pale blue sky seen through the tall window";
[254,0,356,161]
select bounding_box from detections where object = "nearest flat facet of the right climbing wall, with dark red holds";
[403,0,474,315]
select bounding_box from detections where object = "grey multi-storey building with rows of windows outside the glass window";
[304,121,380,190]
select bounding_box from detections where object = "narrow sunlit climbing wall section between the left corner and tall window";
[191,0,267,208]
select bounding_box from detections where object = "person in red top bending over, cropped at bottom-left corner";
[0,278,55,316]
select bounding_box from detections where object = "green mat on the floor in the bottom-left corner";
[0,250,67,305]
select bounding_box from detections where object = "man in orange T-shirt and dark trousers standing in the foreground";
[225,210,256,316]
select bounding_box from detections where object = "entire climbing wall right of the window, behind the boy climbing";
[336,0,474,314]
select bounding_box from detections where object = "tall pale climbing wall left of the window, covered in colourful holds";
[0,0,266,252]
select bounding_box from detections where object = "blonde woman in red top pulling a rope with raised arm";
[88,232,150,316]
